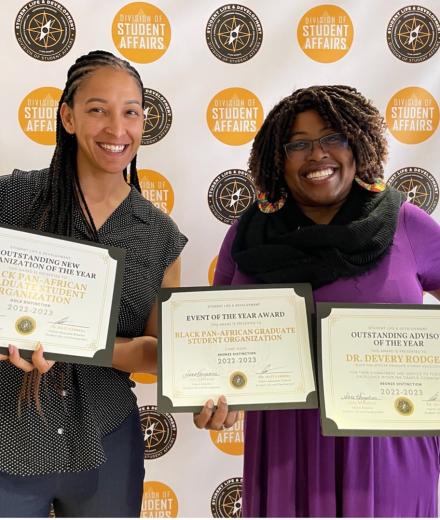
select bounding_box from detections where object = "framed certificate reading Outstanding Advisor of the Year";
[317,303,440,436]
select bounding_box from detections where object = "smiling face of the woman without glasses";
[60,67,143,180]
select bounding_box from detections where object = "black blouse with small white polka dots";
[0,170,187,476]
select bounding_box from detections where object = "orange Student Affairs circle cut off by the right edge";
[385,87,439,144]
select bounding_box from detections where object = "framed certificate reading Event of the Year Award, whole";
[158,284,317,412]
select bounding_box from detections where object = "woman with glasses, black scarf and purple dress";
[194,85,440,517]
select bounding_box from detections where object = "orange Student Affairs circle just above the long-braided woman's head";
[112,2,171,63]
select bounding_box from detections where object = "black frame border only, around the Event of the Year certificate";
[157,283,318,413]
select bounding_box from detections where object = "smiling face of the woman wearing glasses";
[284,110,356,223]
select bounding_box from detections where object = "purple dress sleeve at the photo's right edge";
[402,203,440,291]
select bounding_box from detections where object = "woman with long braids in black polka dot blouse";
[0,51,186,517]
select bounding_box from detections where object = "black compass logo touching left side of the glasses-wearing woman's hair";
[208,170,256,224]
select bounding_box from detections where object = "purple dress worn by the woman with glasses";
[215,203,440,517]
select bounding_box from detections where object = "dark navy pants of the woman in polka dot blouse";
[0,409,144,517]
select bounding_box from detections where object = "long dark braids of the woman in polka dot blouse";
[26,50,144,241]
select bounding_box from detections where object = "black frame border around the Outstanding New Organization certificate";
[0,224,126,367]
